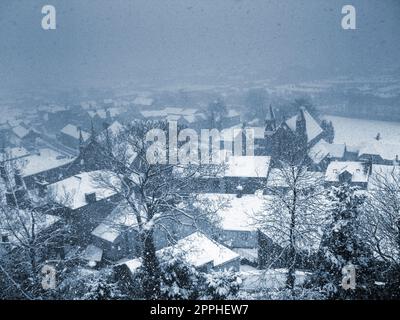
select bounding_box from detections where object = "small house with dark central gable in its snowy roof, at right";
[325,161,371,189]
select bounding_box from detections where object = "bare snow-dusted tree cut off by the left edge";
[0,156,70,299]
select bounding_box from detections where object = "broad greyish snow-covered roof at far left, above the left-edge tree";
[18,148,75,177]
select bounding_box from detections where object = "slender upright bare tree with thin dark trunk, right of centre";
[256,158,326,289]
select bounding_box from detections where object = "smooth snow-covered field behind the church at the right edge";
[324,116,400,146]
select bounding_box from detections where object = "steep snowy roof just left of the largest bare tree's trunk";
[92,201,137,243]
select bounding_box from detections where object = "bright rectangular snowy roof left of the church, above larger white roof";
[224,156,271,178]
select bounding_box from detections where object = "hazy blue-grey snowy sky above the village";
[0,0,400,89]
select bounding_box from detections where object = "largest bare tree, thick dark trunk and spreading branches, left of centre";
[93,121,225,299]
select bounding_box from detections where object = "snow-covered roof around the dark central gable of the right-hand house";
[325,161,368,182]
